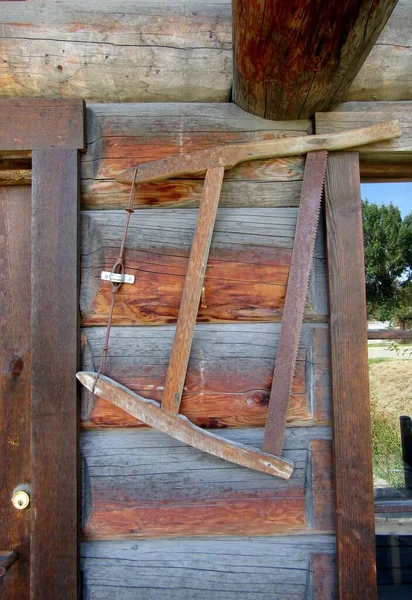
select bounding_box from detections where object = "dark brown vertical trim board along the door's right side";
[31,149,79,600]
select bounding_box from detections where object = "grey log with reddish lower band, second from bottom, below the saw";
[82,427,333,540]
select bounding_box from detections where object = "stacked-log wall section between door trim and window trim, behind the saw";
[80,103,335,600]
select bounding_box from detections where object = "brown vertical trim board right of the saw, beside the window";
[325,152,377,600]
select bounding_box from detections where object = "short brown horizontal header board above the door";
[0,99,85,151]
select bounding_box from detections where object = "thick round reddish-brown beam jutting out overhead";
[232,0,397,119]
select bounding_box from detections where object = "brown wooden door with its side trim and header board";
[0,100,84,600]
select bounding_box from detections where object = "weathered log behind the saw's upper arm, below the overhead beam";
[82,103,312,208]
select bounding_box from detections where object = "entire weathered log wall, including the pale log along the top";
[0,0,412,600]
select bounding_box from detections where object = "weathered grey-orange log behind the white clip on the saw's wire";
[80,208,328,325]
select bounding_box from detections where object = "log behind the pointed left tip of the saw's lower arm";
[82,323,330,428]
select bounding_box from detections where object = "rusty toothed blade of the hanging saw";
[263,151,328,456]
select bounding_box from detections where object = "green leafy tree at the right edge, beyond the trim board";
[362,200,412,326]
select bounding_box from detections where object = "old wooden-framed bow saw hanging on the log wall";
[77,121,400,479]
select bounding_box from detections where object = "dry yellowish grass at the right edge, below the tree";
[369,358,412,488]
